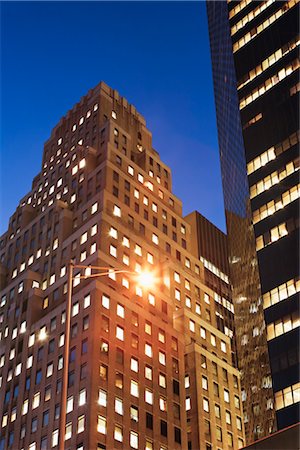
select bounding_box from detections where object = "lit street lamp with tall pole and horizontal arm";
[59,260,156,450]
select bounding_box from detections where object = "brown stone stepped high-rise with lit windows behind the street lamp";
[0,83,245,450]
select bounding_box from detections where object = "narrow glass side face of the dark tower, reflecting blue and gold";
[207,2,274,442]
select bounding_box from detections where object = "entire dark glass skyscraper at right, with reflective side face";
[207,0,300,441]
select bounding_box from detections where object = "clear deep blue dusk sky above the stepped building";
[0,1,225,234]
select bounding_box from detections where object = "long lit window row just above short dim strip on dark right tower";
[240,58,300,109]
